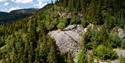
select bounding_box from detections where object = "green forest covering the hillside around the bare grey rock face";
[0,0,125,63]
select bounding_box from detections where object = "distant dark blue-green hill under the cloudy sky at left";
[0,8,39,24]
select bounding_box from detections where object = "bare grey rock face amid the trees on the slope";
[48,25,84,57]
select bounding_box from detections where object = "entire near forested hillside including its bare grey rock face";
[0,0,125,63]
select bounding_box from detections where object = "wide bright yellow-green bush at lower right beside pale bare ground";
[94,45,118,60]
